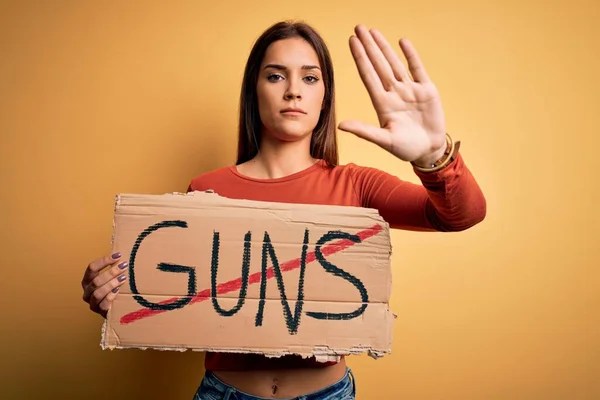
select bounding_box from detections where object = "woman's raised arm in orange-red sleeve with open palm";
[339,25,486,231]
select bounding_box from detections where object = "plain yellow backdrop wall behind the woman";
[0,0,600,400]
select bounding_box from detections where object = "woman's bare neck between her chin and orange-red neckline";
[238,137,318,179]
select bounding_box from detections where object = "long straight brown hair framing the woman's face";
[236,21,339,166]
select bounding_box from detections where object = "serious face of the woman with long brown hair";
[257,38,325,141]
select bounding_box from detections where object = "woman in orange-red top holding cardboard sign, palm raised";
[82,22,486,400]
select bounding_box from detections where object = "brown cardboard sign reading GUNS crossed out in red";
[101,192,395,360]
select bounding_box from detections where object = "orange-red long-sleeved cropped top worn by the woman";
[188,153,486,370]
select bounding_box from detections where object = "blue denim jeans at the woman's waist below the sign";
[194,368,356,400]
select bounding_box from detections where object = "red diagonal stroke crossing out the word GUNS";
[121,224,383,325]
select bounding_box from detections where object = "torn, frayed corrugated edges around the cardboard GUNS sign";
[100,190,397,362]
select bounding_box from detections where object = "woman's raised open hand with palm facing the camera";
[339,25,446,166]
